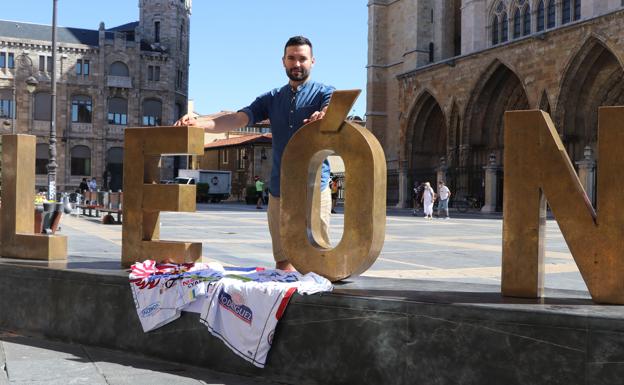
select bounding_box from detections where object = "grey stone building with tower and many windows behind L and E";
[0,0,191,191]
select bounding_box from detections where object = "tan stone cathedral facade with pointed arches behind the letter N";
[367,0,624,211]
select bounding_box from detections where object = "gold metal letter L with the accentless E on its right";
[0,135,67,260]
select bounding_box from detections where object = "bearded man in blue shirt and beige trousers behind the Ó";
[175,36,334,270]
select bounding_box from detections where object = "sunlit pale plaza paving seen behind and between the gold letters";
[61,203,587,291]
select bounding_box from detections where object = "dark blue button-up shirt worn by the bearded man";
[240,80,334,197]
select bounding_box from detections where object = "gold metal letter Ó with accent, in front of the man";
[280,90,386,281]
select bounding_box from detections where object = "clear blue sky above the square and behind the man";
[0,0,368,116]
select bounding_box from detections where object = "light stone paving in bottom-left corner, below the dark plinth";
[0,331,277,385]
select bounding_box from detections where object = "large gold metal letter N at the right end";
[501,107,624,304]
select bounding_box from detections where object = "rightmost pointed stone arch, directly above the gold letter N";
[556,36,624,161]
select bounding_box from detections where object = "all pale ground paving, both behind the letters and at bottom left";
[0,204,588,385]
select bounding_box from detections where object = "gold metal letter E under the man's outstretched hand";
[121,127,204,267]
